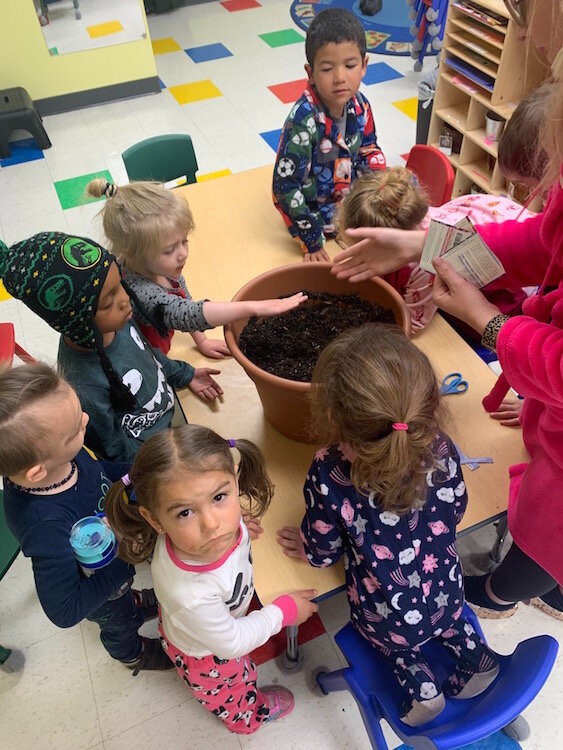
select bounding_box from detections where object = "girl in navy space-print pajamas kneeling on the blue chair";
[278,324,499,726]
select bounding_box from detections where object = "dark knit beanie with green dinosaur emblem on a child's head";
[0,232,115,348]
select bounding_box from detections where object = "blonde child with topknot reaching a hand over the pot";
[86,179,306,359]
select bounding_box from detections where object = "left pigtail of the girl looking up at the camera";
[104,479,158,565]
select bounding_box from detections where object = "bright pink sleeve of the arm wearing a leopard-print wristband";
[497,315,563,407]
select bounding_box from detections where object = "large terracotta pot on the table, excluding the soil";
[225,263,411,443]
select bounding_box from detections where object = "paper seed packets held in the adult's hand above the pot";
[420,217,504,289]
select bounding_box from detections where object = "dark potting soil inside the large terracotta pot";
[239,290,395,382]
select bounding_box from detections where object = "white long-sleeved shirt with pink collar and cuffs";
[151,522,296,659]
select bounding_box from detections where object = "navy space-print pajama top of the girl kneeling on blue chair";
[301,437,467,651]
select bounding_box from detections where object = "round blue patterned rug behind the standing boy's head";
[290,0,435,55]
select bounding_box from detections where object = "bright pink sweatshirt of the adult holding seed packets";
[477,178,563,584]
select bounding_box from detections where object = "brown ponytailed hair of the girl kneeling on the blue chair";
[312,323,448,514]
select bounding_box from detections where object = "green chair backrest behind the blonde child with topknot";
[121,133,198,184]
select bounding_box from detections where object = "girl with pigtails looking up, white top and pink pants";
[105,425,317,734]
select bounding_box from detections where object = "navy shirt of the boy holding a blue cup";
[4,448,135,628]
